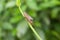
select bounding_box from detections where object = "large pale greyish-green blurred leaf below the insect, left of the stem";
[17,20,28,38]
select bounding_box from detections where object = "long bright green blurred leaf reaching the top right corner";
[39,1,60,10]
